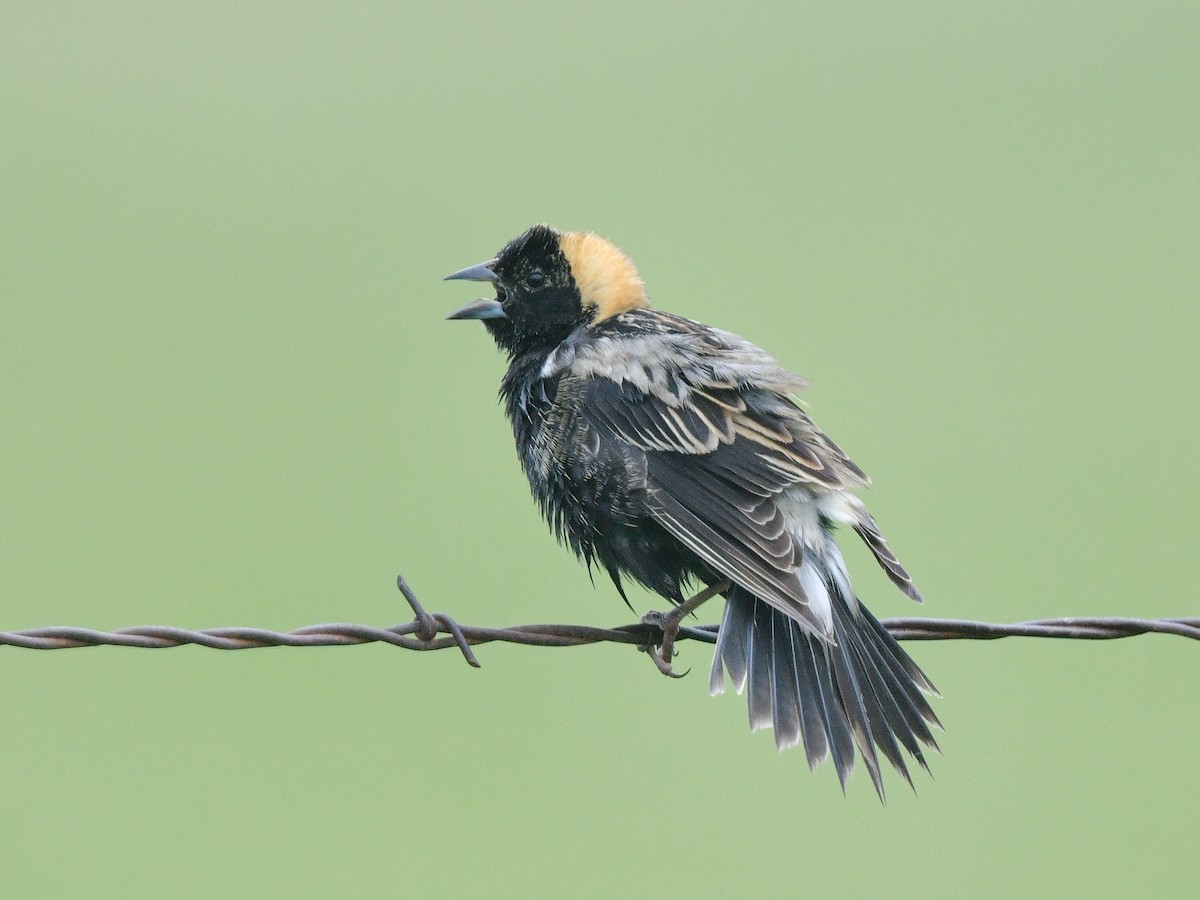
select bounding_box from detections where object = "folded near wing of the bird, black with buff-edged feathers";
[564,311,902,635]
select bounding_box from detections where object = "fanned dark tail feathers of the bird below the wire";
[708,578,941,800]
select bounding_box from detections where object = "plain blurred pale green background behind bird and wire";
[0,2,1200,898]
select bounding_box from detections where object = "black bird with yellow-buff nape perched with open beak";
[448,226,940,799]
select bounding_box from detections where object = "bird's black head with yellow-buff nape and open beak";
[446,226,649,355]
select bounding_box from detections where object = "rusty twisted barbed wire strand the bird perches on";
[0,576,1200,668]
